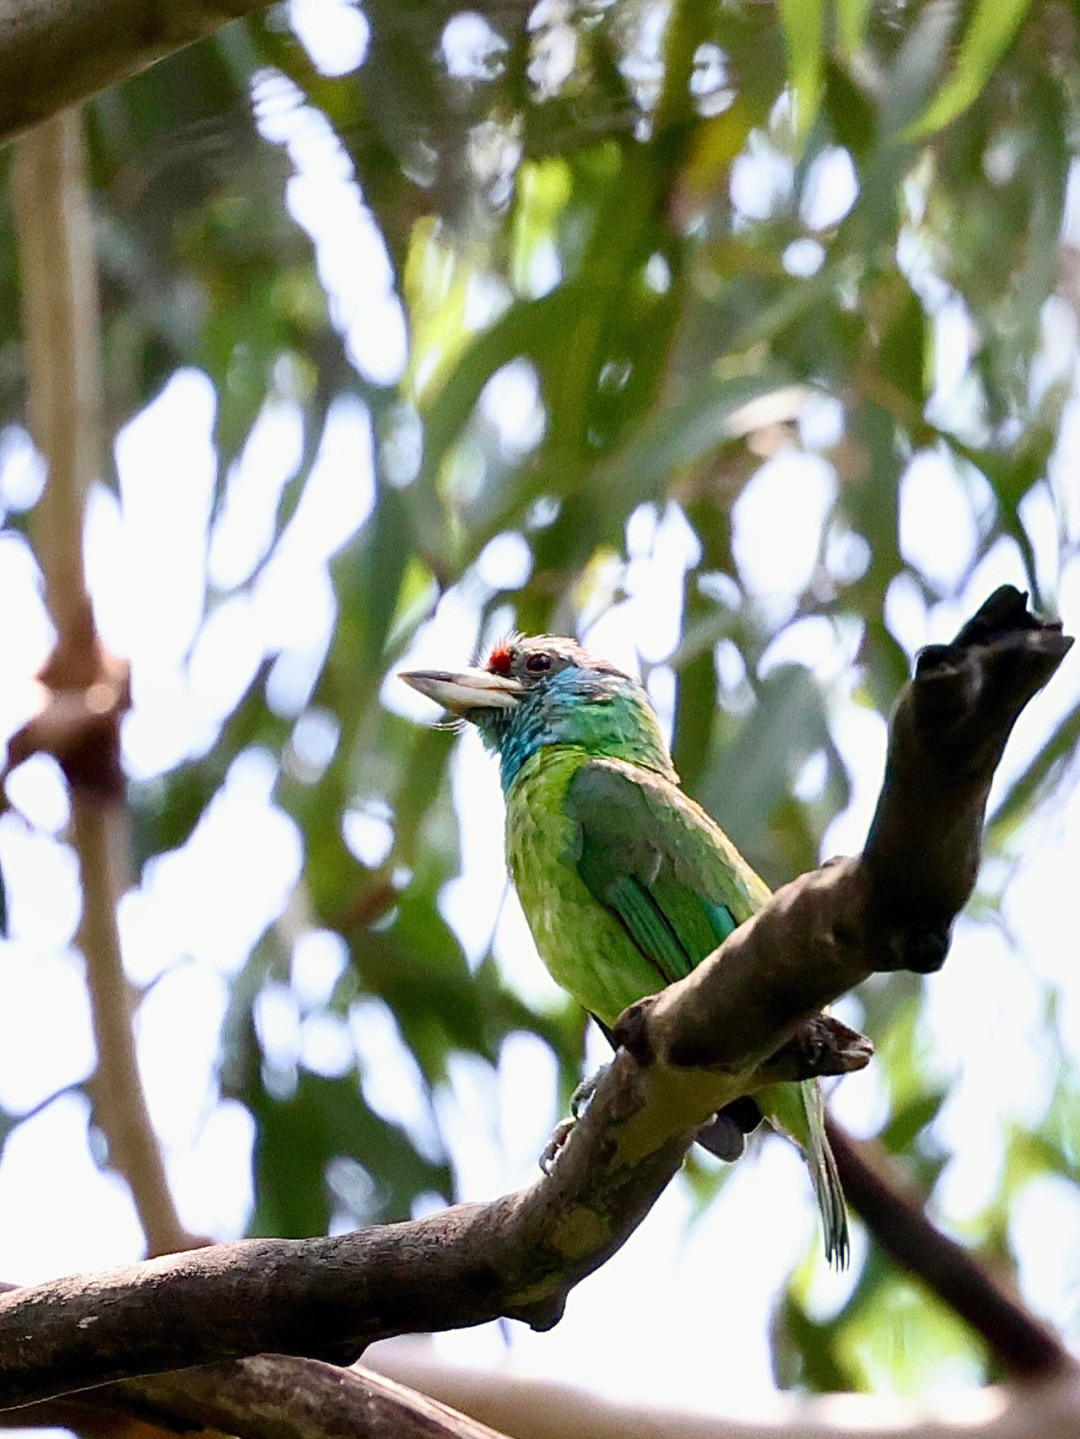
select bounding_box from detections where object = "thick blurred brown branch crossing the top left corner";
[0,0,266,144]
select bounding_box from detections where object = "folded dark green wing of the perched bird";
[567,760,768,984]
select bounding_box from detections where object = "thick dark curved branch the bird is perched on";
[0,589,1071,1404]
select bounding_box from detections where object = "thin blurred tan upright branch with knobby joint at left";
[12,112,191,1253]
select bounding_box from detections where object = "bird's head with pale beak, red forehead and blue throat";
[401,635,677,790]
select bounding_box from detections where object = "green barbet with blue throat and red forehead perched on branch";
[401,635,848,1268]
